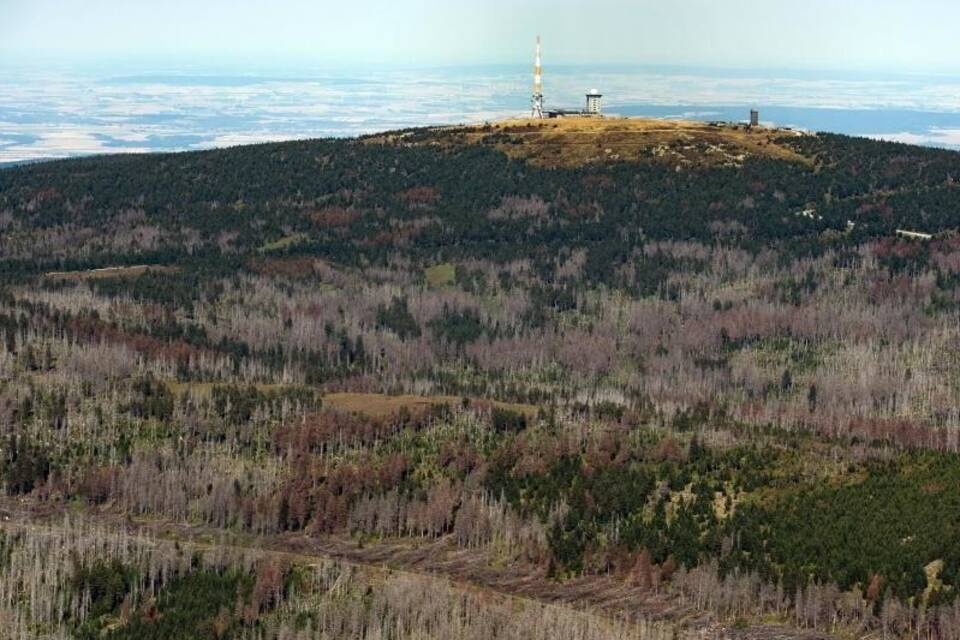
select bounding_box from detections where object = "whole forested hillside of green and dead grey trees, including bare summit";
[0,120,960,639]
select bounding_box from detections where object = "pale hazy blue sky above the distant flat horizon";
[0,0,960,72]
